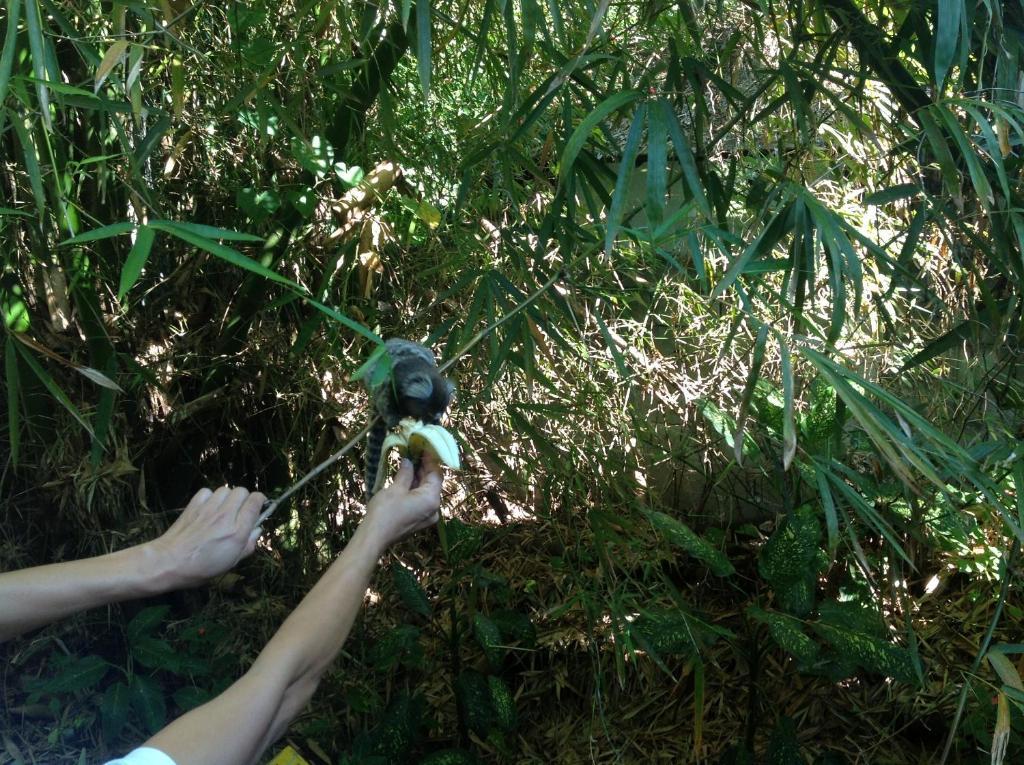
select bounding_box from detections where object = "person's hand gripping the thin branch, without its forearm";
[150,486,266,587]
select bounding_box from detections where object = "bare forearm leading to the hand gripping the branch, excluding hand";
[0,545,177,641]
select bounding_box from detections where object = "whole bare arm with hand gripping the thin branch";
[0,486,266,641]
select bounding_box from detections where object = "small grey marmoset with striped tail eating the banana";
[364,338,455,500]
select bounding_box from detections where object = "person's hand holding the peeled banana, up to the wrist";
[360,451,441,551]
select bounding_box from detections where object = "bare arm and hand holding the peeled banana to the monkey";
[145,454,441,765]
